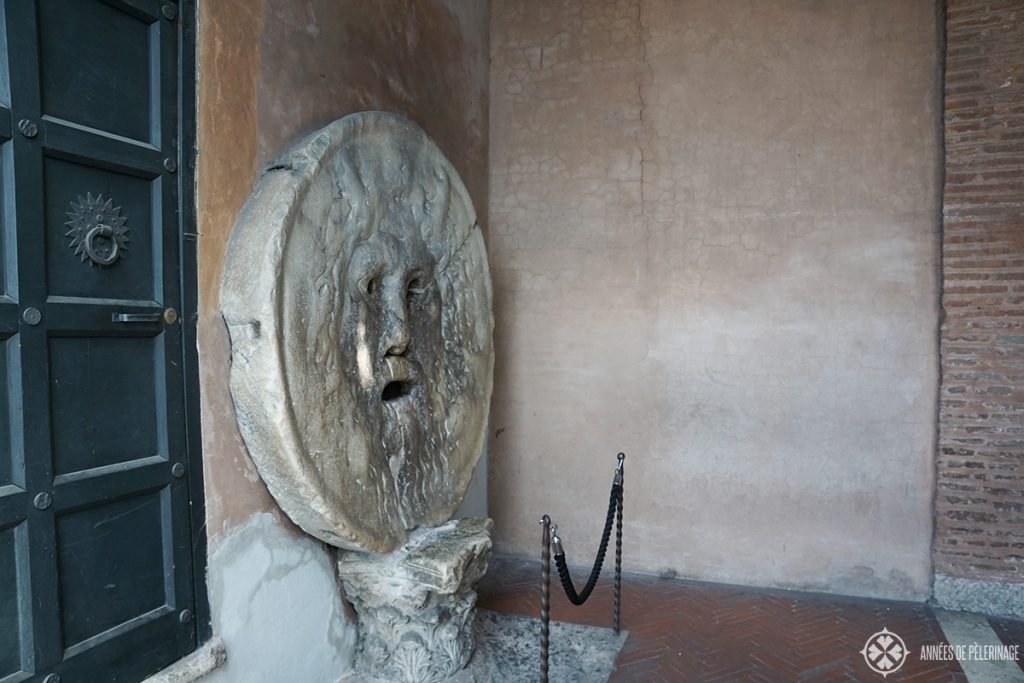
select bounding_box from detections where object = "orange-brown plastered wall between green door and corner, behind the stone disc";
[197,0,488,683]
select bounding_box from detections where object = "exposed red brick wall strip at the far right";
[934,0,1024,582]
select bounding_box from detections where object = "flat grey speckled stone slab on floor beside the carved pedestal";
[340,609,628,683]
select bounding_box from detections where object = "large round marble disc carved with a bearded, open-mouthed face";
[221,113,494,552]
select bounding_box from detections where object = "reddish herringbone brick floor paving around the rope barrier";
[479,557,967,683]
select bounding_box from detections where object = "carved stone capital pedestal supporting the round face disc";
[338,517,494,683]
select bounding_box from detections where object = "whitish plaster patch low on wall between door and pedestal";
[204,513,356,683]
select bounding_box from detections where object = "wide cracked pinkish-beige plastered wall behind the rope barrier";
[488,0,940,599]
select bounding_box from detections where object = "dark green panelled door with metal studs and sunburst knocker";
[0,0,196,683]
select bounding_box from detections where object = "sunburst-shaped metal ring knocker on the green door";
[65,193,129,267]
